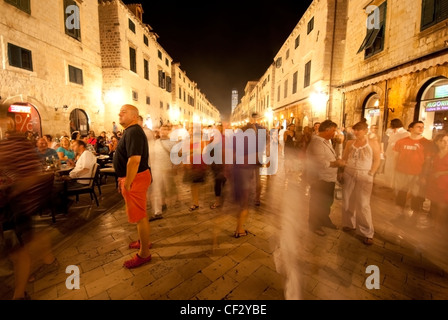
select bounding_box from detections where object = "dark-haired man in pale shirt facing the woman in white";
[306,120,344,236]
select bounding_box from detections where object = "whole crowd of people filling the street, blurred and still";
[0,105,448,299]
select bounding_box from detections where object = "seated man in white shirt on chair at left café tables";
[63,140,96,189]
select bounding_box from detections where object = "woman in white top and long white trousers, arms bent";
[342,122,381,245]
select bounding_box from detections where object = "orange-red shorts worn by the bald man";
[118,170,151,223]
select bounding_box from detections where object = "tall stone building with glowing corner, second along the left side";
[98,0,172,130]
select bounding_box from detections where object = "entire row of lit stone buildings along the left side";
[0,0,220,138]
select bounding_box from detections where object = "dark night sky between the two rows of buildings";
[123,0,312,120]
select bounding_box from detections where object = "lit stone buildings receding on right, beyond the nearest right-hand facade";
[233,0,348,127]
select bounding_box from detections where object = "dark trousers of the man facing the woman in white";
[308,180,336,230]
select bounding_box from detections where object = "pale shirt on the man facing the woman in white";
[306,135,338,182]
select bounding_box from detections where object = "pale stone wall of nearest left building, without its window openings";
[0,0,103,135]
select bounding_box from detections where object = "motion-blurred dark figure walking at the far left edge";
[0,116,55,300]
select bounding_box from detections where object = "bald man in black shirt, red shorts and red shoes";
[114,104,151,269]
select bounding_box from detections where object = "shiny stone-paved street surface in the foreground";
[0,159,448,300]
